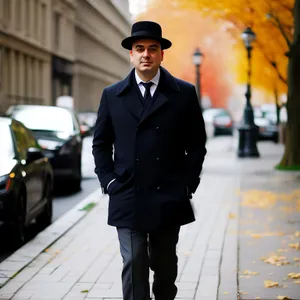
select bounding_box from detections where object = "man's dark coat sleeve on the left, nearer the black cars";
[92,89,115,193]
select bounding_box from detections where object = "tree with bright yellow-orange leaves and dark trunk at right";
[168,0,300,169]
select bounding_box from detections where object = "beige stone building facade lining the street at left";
[0,0,131,113]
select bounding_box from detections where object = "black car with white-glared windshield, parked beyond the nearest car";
[7,105,82,190]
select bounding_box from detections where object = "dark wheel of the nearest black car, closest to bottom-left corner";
[8,190,26,249]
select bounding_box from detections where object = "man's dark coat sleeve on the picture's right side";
[185,87,207,193]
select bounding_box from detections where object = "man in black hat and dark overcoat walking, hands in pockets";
[93,21,206,300]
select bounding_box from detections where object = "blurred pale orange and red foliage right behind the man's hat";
[137,0,235,107]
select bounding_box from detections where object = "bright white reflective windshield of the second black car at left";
[13,106,74,133]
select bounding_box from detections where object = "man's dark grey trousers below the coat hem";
[117,227,180,300]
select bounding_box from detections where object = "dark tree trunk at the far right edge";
[279,0,300,169]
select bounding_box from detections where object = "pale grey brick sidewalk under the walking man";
[0,138,300,300]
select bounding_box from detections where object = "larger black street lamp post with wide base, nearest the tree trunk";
[238,27,259,157]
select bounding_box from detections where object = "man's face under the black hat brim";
[130,40,164,75]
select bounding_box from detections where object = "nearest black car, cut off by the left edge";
[0,117,53,246]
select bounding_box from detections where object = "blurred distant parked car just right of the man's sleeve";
[203,108,233,138]
